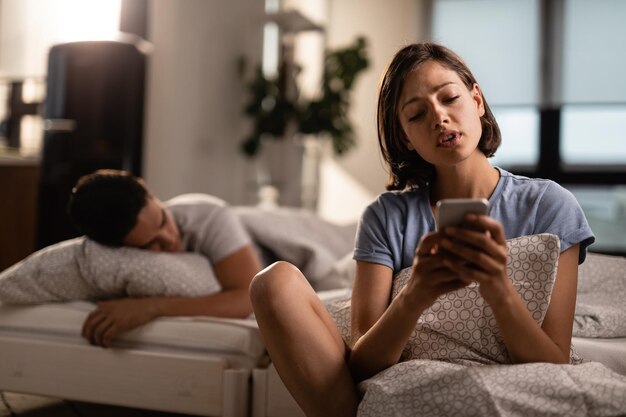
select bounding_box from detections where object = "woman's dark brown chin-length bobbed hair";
[377,42,501,190]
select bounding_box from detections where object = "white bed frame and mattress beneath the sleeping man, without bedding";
[0,280,626,417]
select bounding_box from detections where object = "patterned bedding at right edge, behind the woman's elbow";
[573,253,626,337]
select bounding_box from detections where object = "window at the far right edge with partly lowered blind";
[560,0,626,169]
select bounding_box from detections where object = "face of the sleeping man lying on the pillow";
[123,196,183,252]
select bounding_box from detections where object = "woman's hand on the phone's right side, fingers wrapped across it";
[441,214,511,304]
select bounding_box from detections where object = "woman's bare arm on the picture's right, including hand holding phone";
[442,216,579,363]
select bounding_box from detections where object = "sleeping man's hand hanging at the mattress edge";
[82,298,158,347]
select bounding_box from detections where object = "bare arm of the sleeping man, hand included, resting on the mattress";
[82,245,261,347]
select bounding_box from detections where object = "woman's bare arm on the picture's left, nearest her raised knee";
[349,233,467,382]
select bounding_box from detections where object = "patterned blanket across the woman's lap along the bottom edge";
[358,360,626,417]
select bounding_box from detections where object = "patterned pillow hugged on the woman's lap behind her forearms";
[327,234,560,363]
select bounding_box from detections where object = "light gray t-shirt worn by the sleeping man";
[165,194,251,265]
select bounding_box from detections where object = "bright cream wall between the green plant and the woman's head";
[319,0,426,222]
